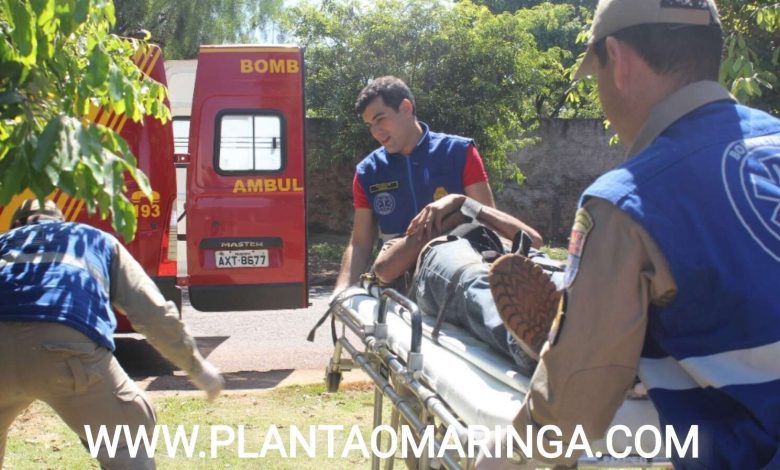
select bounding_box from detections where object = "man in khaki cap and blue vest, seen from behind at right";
[481,0,780,469]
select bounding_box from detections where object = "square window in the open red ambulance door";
[218,114,284,171]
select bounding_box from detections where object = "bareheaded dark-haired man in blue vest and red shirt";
[334,76,495,293]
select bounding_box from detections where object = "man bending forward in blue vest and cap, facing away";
[0,199,223,468]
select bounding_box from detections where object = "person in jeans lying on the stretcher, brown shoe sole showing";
[373,194,562,376]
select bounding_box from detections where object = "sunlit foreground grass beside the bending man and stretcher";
[4,384,403,470]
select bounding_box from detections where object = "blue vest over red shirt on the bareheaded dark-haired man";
[356,123,473,241]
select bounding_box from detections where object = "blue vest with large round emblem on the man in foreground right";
[580,101,780,469]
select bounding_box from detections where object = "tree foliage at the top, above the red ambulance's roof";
[114,0,284,59]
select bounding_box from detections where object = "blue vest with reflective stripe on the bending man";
[0,221,118,350]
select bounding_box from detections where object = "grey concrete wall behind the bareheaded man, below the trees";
[306,119,625,242]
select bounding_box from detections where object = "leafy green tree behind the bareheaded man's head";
[288,0,572,184]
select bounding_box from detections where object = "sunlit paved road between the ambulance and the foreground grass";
[116,287,365,391]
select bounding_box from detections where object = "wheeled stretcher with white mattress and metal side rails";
[326,280,671,469]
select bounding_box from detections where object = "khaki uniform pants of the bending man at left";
[0,321,155,469]
